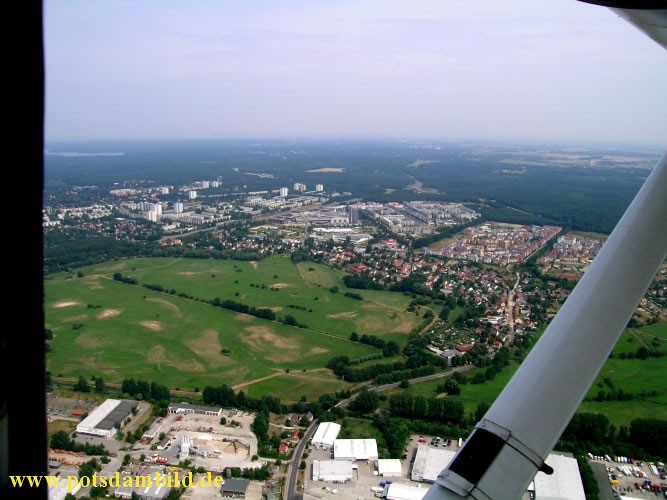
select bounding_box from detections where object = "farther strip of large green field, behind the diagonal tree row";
[66,257,420,343]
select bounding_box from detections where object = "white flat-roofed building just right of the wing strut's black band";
[528,453,586,500]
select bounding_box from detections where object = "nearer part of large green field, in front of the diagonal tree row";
[45,278,377,390]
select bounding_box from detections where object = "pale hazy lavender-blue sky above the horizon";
[44,0,667,145]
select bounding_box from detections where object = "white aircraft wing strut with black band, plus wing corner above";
[424,0,667,500]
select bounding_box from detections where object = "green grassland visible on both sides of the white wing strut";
[386,323,667,427]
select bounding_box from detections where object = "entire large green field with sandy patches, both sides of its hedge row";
[45,257,420,399]
